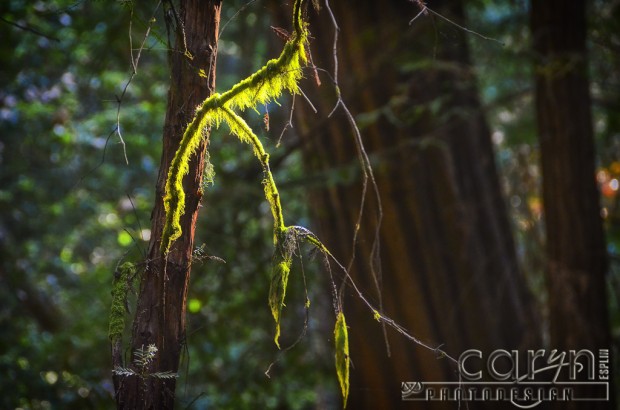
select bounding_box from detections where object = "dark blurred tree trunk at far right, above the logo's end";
[531,0,615,409]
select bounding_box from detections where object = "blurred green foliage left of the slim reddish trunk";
[0,0,167,409]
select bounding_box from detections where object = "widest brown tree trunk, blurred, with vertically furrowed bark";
[284,1,539,409]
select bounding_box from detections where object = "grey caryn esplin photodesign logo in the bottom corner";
[401,349,610,409]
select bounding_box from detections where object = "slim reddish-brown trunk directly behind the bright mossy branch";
[113,0,221,409]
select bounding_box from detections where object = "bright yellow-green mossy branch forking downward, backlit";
[160,0,349,405]
